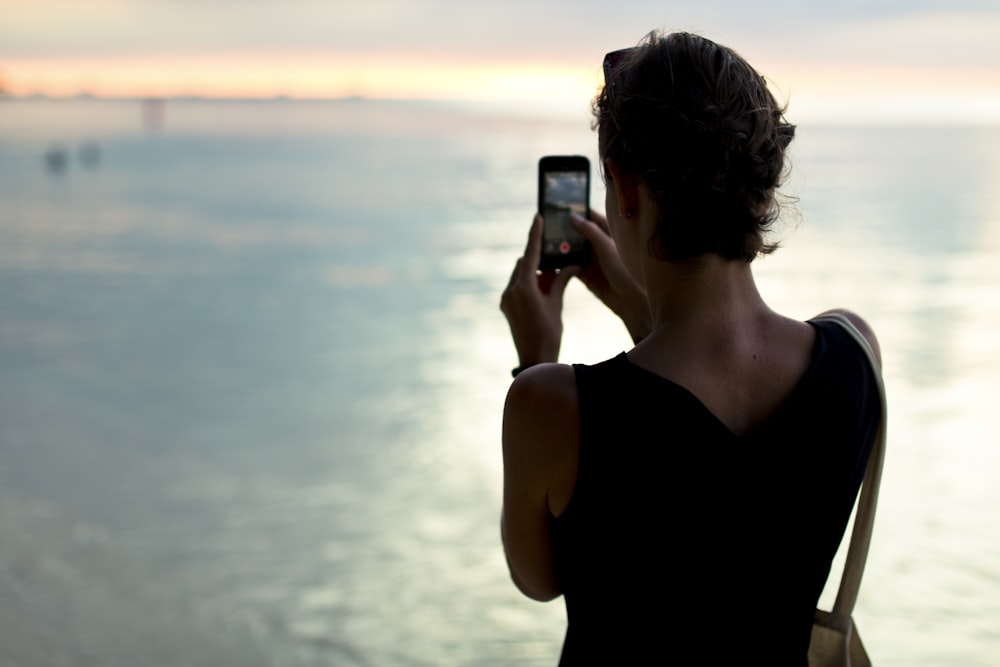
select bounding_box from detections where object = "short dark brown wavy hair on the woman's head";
[593,32,795,262]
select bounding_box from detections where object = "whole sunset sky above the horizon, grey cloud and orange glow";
[0,0,1000,123]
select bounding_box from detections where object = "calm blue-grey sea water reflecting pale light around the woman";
[0,100,1000,667]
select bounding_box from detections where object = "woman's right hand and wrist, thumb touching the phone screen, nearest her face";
[573,209,651,343]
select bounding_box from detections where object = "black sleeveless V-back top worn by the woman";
[551,322,881,665]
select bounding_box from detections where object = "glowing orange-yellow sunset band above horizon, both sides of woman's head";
[0,53,1000,123]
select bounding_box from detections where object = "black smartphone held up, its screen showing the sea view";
[538,155,590,271]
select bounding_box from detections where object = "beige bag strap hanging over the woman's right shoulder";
[813,313,887,619]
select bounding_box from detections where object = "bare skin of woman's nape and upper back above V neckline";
[612,255,815,434]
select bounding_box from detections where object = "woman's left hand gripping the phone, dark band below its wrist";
[500,215,580,366]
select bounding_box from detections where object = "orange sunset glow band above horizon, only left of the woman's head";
[4,53,597,100]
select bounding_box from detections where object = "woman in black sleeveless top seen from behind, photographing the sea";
[501,33,880,665]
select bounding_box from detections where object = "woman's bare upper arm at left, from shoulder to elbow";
[501,364,579,601]
